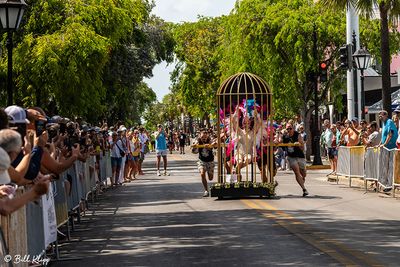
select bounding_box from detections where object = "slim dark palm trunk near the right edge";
[379,5,392,118]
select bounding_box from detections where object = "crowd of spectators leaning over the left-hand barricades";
[0,106,155,218]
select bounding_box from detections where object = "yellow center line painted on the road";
[242,200,383,266]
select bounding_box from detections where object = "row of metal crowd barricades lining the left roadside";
[0,152,112,266]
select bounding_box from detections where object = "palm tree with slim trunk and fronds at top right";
[321,0,400,113]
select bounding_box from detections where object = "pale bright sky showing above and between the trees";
[145,0,236,101]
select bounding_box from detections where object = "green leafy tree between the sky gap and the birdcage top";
[172,17,224,125]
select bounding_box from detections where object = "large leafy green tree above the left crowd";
[0,0,174,123]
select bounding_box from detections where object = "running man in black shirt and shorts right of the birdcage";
[280,124,308,197]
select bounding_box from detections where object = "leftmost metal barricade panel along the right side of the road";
[336,146,365,187]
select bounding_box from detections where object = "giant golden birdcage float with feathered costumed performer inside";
[211,72,276,198]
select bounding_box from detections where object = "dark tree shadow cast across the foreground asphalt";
[54,177,400,267]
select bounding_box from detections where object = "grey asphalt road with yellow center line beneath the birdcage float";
[52,152,400,267]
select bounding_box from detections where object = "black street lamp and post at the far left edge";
[0,0,28,106]
